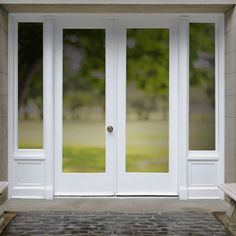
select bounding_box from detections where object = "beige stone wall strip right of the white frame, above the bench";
[225,7,236,182]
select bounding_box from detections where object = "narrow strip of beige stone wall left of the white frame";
[0,8,8,202]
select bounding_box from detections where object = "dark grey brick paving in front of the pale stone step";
[3,212,229,236]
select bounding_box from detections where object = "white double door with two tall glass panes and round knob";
[54,16,178,195]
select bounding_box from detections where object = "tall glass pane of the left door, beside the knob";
[63,29,105,173]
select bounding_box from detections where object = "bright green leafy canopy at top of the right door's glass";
[127,29,169,96]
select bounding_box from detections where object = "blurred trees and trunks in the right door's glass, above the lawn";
[127,29,169,120]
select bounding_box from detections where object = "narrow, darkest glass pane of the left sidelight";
[18,23,43,149]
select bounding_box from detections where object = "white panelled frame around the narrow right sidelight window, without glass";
[184,14,224,199]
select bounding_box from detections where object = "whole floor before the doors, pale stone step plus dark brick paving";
[0,198,230,236]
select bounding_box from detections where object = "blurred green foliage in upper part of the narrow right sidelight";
[189,23,215,106]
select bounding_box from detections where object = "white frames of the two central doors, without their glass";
[54,17,178,196]
